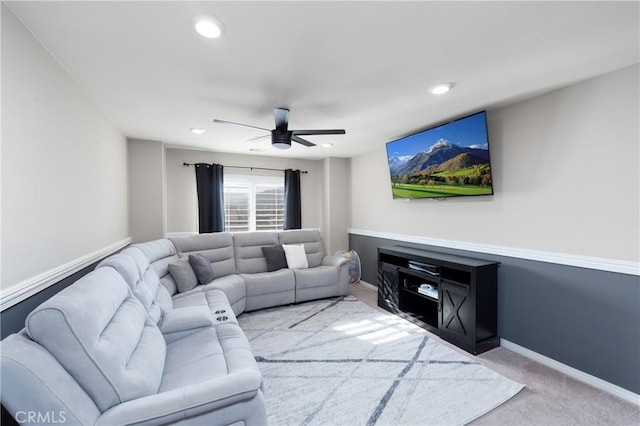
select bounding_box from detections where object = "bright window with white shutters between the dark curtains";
[224,175,284,232]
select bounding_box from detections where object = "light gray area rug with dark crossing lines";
[238,296,524,426]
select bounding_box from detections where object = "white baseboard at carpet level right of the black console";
[500,339,640,405]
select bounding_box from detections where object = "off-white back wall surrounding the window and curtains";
[166,148,323,233]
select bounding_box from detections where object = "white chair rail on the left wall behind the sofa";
[0,237,131,312]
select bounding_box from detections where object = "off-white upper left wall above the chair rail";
[1,4,128,290]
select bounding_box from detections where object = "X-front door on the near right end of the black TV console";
[438,280,475,342]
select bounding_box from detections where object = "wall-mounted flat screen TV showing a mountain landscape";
[387,111,493,199]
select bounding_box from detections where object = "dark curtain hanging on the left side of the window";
[195,163,224,234]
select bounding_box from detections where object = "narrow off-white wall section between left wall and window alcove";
[127,139,167,242]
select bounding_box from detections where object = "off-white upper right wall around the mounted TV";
[350,65,640,261]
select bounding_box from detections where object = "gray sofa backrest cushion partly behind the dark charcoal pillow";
[233,231,278,274]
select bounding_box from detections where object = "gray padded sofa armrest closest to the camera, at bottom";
[96,368,262,425]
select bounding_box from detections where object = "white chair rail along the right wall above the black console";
[348,228,640,275]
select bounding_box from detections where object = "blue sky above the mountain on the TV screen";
[387,111,489,158]
